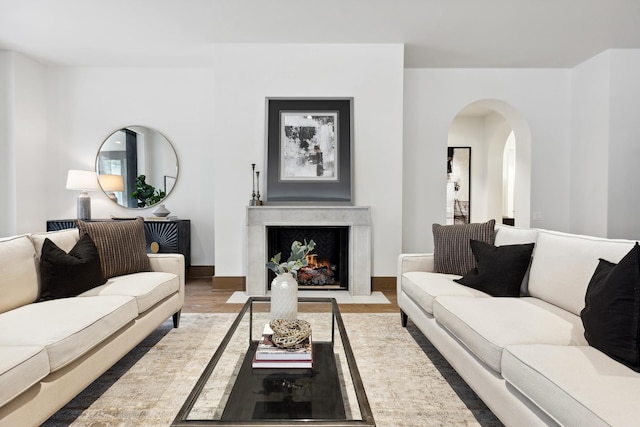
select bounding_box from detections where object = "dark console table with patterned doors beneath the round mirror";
[47,219,191,268]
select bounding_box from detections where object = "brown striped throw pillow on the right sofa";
[433,219,496,276]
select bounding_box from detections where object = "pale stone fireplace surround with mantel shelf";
[246,206,371,296]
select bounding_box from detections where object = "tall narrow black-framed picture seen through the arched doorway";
[446,147,471,224]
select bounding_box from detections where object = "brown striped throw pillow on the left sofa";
[76,218,151,279]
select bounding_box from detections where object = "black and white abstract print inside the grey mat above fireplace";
[280,111,339,181]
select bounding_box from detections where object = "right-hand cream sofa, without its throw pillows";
[397,226,640,427]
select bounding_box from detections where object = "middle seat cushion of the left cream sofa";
[0,296,138,372]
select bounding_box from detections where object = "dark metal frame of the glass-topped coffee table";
[172,297,375,427]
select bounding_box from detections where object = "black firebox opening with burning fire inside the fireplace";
[267,226,349,290]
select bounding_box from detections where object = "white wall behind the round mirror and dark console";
[41,68,218,265]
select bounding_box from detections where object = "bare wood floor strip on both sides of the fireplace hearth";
[182,278,400,313]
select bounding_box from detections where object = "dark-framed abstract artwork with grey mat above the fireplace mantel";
[265,98,353,204]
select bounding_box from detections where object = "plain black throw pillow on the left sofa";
[40,234,106,301]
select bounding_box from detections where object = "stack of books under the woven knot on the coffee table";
[251,324,313,369]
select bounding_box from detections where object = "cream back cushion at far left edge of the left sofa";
[0,236,39,313]
